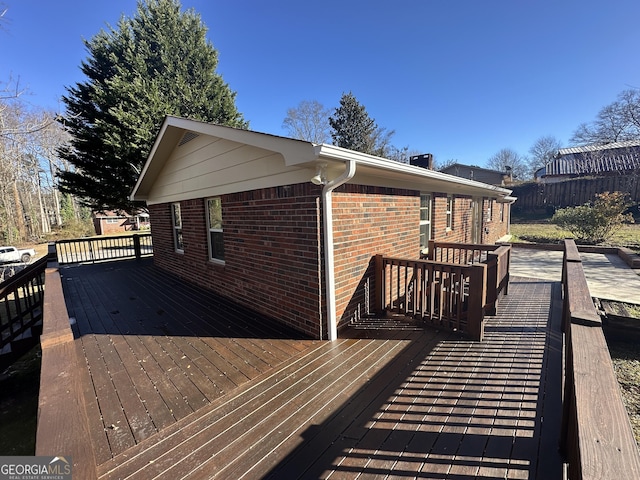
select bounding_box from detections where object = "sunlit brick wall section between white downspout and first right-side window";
[333,185,420,327]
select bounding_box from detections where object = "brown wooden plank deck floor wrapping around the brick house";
[60,260,562,479]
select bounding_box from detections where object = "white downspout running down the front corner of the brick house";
[322,160,356,341]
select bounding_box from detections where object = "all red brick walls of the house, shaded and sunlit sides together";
[150,184,508,338]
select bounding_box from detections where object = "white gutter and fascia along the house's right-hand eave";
[316,144,511,198]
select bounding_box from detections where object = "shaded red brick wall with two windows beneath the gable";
[150,184,326,338]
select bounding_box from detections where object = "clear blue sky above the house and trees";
[0,0,640,165]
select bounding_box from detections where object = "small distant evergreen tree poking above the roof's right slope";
[329,92,378,154]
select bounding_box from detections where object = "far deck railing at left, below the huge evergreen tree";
[56,233,153,265]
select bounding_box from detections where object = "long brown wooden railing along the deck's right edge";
[561,240,640,480]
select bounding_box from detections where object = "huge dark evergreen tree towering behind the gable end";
[59,0,247,210]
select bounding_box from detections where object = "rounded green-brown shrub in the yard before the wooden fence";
[551,192,633,244]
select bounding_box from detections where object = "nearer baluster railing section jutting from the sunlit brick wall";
[375,255,487,340]
